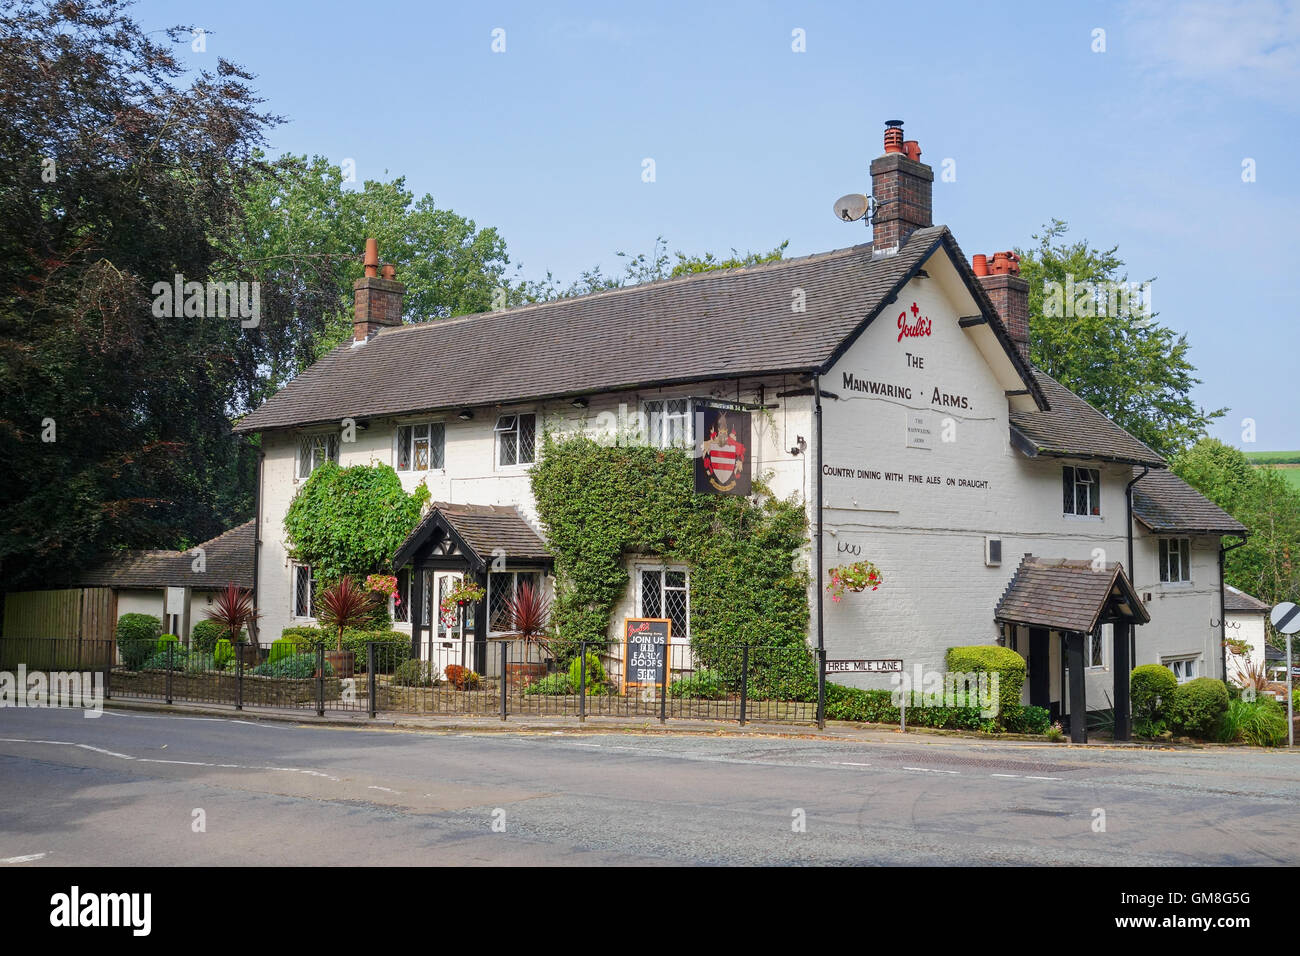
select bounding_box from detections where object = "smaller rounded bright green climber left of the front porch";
[285,462,429,584]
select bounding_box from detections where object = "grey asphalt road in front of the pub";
[0,709,1300,866]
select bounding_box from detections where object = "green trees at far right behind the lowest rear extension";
[1170,438,1300,605]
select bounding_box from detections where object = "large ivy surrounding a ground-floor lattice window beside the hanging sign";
[532,436,815,697]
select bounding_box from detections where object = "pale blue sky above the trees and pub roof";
[134,0,1300,450]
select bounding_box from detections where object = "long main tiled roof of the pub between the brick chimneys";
[235,226,1045,432]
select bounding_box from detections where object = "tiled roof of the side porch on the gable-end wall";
[995,555,1151,633]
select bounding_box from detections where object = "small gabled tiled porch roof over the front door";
[393,501,551,572]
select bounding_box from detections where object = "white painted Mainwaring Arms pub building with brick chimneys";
[238,126,1245,743]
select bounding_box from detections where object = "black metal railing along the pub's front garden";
[0,636,824,724]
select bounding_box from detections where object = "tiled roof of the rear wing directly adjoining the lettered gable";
[1010,369,1165,468]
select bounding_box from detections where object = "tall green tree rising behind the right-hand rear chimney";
[1017,220,1226,455]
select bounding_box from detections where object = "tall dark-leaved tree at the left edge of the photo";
[0,0,276,588]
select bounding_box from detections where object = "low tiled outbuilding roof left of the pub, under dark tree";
[77,522,256,589]
